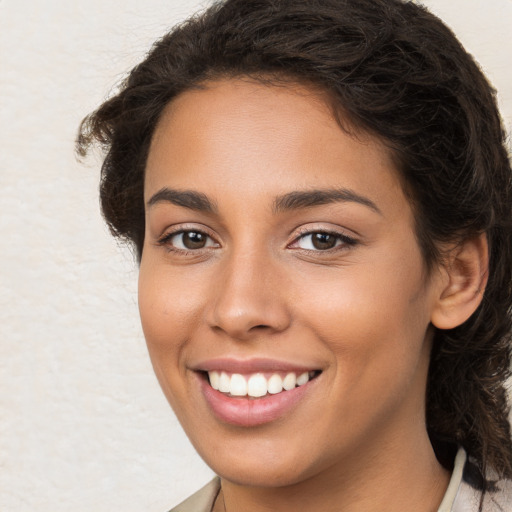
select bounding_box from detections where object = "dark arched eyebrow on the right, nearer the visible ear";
[273,188,382,215]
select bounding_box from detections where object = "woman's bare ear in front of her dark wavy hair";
[431,233,489,329]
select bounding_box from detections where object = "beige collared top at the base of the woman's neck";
[170,448,512,512]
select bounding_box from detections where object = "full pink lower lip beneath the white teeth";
[200,376,316,427]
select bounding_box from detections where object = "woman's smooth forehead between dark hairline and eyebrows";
[145,79,405,216]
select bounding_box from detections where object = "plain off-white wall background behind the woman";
[0,0,512,512]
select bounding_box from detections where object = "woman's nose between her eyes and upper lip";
[208,248,290,340]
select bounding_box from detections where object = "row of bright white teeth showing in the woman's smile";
[208,371,314,398]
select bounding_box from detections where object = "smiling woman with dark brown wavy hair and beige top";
[78,0,512,512]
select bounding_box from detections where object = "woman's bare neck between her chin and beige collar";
[218,432,449,512]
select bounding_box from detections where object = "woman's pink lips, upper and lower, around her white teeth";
[196,359,318,428]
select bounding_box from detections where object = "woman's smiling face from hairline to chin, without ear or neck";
[139,80,439,486]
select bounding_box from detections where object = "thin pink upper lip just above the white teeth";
[193,357,320,374]
